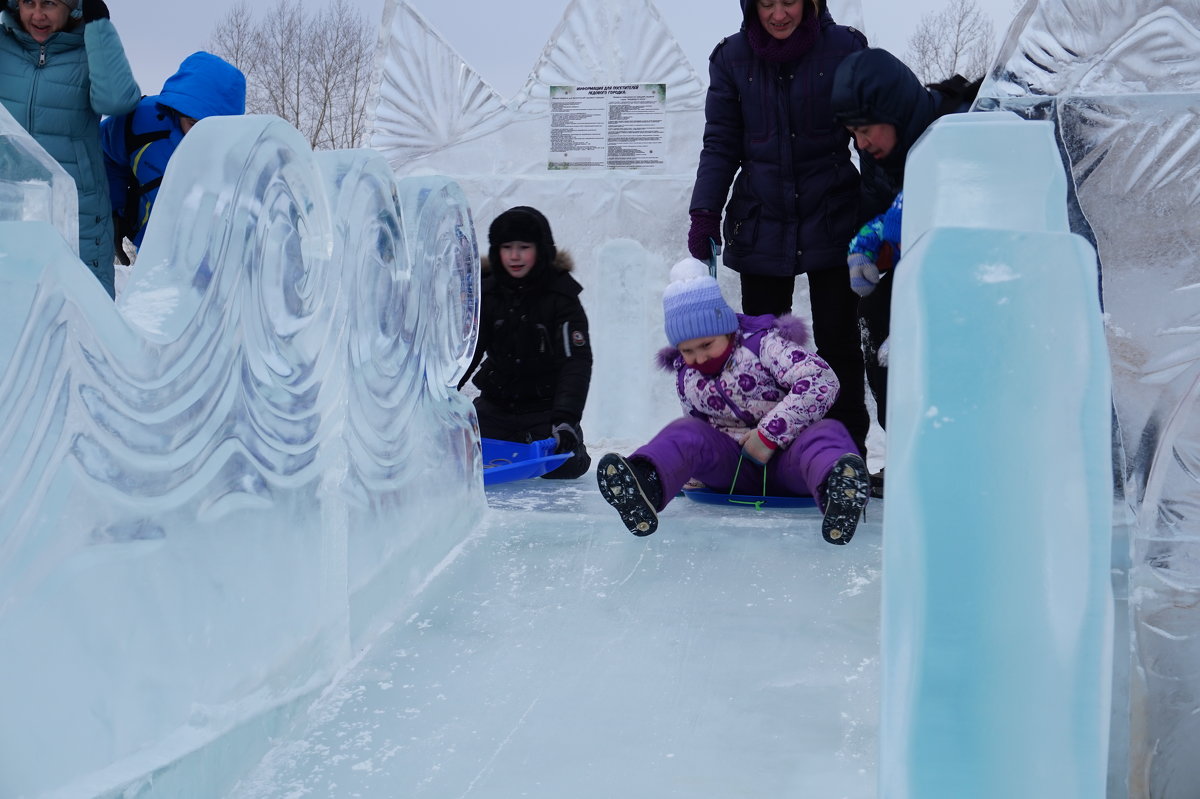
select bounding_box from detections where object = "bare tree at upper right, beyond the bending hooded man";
[905,0,996,83]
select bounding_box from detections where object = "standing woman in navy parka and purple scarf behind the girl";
[688,0,869,450]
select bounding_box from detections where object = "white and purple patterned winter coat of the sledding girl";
[659,313,840,447]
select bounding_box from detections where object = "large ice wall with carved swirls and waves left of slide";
[0,116,484,797]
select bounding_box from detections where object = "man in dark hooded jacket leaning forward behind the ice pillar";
[833,48,983,493]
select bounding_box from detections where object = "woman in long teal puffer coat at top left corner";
[0,0,142,296]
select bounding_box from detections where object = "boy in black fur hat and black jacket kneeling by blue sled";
[458,205,592,479]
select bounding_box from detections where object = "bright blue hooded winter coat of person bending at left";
[100,52,246,247]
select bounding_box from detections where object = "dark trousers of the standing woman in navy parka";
[740,265,871,455]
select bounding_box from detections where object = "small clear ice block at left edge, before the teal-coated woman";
[0,108,79,249]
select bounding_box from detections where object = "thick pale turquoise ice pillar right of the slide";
[880,113,1112,799]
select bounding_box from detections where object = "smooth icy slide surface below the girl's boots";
[229,475,882,799]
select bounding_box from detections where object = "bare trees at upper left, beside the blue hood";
[209,0,374,149]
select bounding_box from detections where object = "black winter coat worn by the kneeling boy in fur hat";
[458,250,592,426]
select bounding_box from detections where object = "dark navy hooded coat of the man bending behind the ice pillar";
[833,48,983,222]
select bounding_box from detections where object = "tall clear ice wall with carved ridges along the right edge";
[979,0,1200,799]
